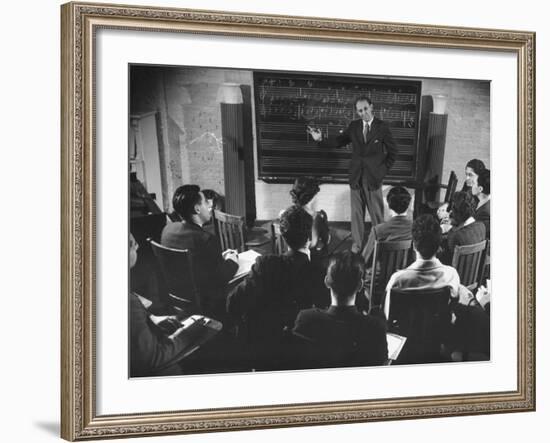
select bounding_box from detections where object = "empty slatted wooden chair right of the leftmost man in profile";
[214,209,271,252]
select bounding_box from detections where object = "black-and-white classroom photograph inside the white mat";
[127,64,497,378]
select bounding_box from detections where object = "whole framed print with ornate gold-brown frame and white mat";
[62,3,535,440]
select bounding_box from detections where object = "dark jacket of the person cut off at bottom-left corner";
[129,293,202,377]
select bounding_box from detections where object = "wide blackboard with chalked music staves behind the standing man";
[254,71,421,183]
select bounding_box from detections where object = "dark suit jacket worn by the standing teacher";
[320,117,397,189]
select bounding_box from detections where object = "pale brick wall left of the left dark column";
[131,67,252,210]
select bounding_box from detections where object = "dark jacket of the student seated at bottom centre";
[293,306,388,367]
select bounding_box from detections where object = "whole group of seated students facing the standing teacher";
[131,161,490,373]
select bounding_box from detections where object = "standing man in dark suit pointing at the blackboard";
[307,96,397,253]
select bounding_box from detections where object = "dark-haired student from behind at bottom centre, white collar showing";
[292,252,388,367]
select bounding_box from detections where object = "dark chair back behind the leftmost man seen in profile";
[148,239,201,311]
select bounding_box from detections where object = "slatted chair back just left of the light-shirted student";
[369,240,412,307]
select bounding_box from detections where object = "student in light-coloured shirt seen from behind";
[384,214,460,318]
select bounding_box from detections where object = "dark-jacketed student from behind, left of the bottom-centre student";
[227,206,329,369]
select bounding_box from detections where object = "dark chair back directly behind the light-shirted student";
[388,286,451,363]
